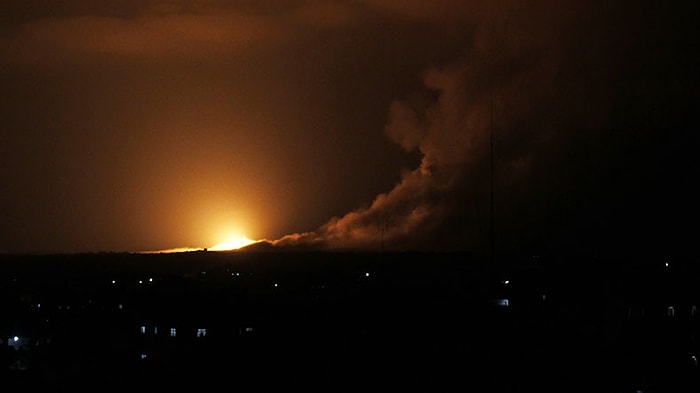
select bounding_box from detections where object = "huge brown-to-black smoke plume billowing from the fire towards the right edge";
[274,2,692,252]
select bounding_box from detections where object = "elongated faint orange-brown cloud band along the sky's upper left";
[2,2,361,64]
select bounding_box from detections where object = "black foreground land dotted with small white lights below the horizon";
[0,251,700,393]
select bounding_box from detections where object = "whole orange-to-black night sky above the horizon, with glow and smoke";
[0,0,700,255]
